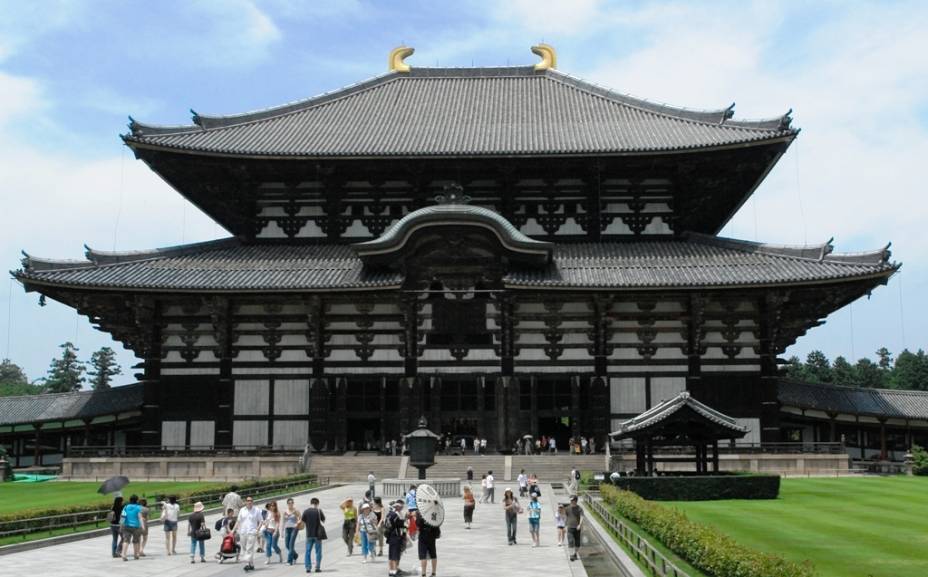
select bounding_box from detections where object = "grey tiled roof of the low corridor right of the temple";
[778,380,928,419]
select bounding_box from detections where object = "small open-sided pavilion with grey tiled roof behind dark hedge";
[609,391,748,475]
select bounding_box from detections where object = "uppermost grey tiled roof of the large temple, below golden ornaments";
[125,66,798,158]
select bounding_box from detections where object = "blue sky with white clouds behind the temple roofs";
[0,0,928,382]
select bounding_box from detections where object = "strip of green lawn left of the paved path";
[0,481,224,514]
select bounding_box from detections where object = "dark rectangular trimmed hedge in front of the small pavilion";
[604,475,780,501]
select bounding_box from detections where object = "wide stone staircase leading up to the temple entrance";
[309,454,606,483]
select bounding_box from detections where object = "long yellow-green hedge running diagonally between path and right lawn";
[600,484,815,577]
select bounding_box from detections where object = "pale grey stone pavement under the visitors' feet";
[2,481,587,577]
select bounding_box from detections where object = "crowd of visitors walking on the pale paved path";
[107,467,583,576]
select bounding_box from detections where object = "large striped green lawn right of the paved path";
[665,477,928,577]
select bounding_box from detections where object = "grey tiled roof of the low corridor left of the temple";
[0,383,142,426]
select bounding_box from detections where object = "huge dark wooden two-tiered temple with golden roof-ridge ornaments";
[15,46,897,450]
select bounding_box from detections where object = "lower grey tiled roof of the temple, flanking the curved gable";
[14,234,898,291]
